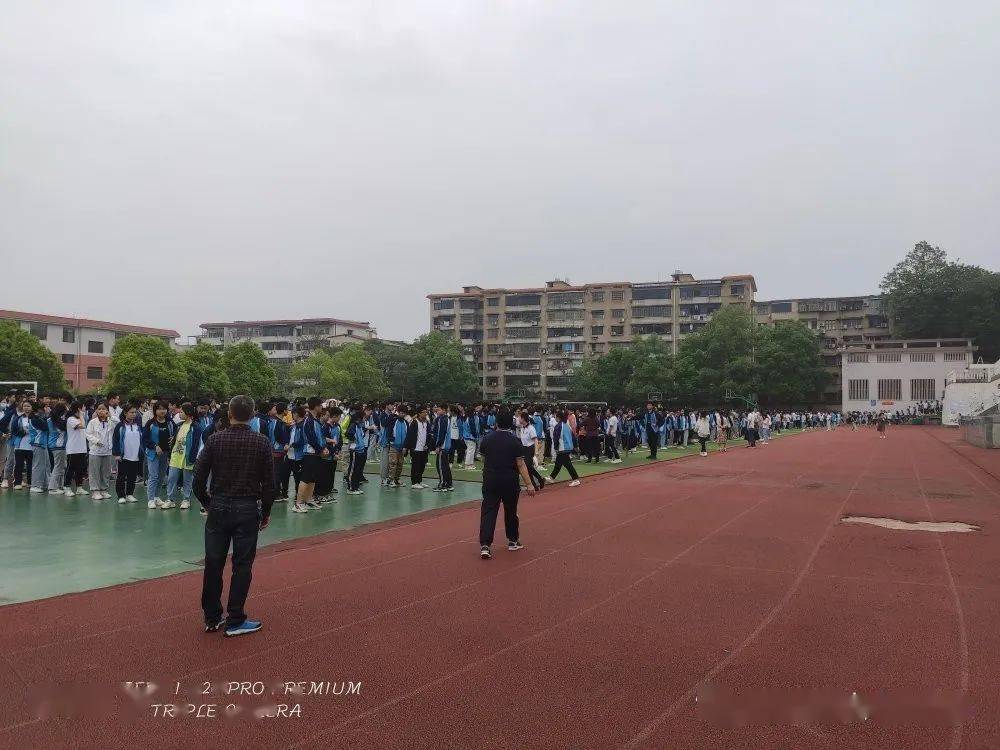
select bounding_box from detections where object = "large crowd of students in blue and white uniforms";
[0,393,861,513]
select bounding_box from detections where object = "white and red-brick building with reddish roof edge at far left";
[0,310,180,393]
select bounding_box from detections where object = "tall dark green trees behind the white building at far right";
[880,242,1000,362]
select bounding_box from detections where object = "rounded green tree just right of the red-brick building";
[102,333,188,397]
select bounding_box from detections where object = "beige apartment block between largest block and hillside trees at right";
[754,295,892,406]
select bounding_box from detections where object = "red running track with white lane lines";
[0,427,1000,750]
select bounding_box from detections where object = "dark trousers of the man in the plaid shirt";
[201,497,261,627]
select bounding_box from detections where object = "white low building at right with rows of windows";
[841,339,976,412]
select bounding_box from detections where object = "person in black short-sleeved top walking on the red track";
[479,412,535,560]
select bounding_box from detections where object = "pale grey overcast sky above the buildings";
[0,0,1000,339]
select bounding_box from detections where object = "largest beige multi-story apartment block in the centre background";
[428,271,757,398]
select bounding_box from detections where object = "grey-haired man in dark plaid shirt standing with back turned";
[194,396,275,636]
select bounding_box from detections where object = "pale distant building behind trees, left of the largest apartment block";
[197,318,377,365]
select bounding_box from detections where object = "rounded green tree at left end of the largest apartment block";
[407,331,480,401]
